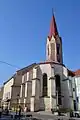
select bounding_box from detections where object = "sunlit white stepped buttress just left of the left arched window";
[30,66,40,111]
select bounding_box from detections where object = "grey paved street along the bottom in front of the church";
[0,113,80,120]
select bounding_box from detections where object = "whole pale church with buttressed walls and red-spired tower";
[3,15,74,111]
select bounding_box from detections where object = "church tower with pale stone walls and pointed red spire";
[46,15,63,63]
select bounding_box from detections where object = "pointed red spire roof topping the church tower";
[48,15,58,38]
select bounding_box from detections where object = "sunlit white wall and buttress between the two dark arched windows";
[40,64,56,111]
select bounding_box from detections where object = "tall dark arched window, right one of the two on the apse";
[55,75,62,105]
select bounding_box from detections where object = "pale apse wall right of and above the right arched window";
[54,64,73,108]
